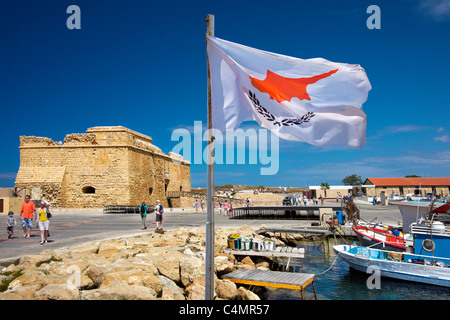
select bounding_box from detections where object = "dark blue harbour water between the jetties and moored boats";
[267,238,450,300]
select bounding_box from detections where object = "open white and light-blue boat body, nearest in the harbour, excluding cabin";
[333,245,450,288]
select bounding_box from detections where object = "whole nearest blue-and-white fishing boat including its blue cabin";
[333,204,450,287]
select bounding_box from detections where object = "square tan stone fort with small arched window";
[15,126,191,208]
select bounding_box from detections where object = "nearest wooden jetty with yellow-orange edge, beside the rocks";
[222,269,317,300]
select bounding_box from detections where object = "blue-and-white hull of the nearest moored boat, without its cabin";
[333,245,450,288]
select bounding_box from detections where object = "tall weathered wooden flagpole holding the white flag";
[205,14,214,300]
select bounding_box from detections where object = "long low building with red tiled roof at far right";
[363,177,450,197]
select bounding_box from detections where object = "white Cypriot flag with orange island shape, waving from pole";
[207,36,371,147]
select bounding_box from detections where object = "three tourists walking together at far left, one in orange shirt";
[6,195,51,244]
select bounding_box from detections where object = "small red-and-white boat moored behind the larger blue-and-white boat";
[352,221,413,251]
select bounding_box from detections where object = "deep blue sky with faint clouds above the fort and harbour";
[0,0,450,187]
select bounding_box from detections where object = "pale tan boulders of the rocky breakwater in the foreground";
[0,226,271,300]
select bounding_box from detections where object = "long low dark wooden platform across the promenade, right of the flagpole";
[230,206,343,220]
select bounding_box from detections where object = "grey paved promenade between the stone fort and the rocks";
[0,201,401,265]
